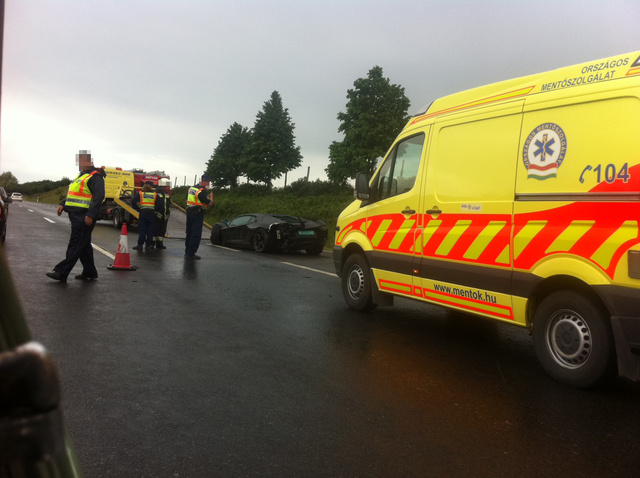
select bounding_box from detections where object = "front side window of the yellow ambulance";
[371,134,424,201]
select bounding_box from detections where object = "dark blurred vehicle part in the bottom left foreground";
[0,247,81,478]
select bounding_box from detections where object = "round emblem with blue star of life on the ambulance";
[522,123,567,180]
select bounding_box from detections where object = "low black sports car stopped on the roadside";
[211,214,327,255]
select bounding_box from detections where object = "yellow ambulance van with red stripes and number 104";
[334,51,640,387]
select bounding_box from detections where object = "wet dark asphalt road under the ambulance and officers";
[5,203,640,478]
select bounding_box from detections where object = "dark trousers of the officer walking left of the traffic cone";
[53,208,98,279]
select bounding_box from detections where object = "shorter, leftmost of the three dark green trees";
[205,123,251,188]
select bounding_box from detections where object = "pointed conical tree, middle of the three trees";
[243,91,302,187]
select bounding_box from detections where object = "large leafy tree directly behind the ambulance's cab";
[325,66,410,183]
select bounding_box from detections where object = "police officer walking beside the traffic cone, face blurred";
[47,151,107,282]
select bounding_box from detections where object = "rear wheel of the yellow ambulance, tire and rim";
[533,290,616,388]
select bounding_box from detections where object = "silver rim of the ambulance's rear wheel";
[545,310,592,369]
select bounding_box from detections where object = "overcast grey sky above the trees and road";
[0,0,640,186]
